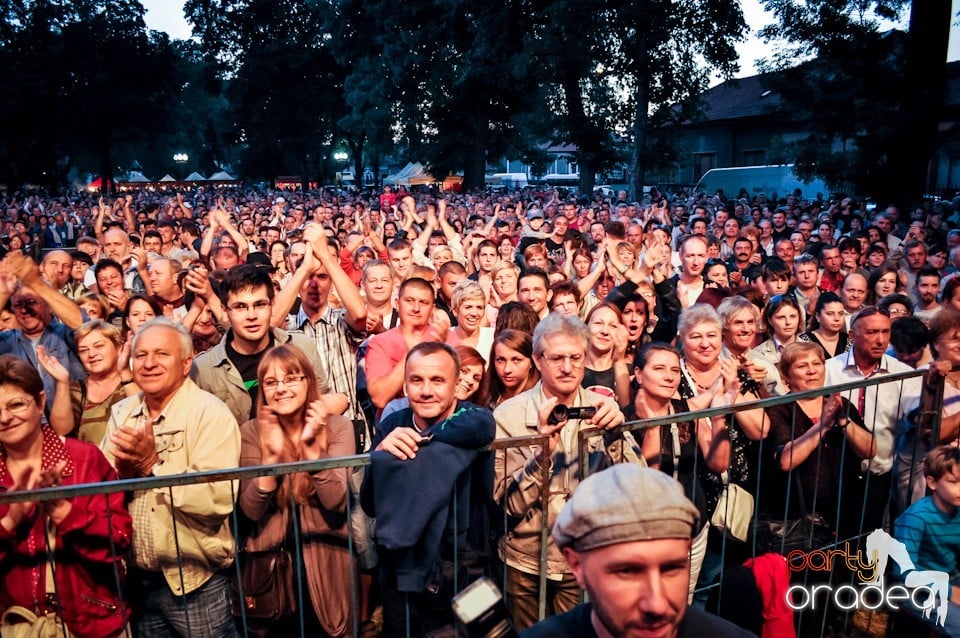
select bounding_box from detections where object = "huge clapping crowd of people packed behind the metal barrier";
[0,186,960,637]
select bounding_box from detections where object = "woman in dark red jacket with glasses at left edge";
[0,355,132,637]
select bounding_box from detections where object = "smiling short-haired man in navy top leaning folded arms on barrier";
[362,341,494,638]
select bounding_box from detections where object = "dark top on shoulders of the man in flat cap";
[520,603,756,638]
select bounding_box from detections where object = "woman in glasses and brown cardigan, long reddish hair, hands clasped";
[238,345,356,637]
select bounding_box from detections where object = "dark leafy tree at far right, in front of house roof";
[761,0,950,203]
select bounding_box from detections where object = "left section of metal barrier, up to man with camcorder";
[0,435,550,638]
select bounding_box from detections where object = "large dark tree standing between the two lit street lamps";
[185,0,343,184]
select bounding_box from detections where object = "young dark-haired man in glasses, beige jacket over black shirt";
[190,264,347,423]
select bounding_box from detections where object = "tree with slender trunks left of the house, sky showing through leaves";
[531,0,746,199]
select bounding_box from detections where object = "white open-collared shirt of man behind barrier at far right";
[824,349,923,474]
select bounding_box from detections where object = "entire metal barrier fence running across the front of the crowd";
[0,372,944,636]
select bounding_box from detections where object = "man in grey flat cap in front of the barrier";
[521,463,753,638]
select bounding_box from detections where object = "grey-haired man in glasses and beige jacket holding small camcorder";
[494,313,640,629]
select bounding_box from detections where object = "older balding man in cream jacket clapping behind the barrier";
[101,319,240,638]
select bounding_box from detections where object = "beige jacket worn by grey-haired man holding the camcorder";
[493,383,644,580]
